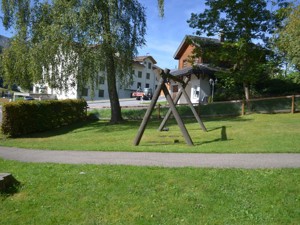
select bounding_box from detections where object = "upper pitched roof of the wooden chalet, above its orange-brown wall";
[173,35,220,59]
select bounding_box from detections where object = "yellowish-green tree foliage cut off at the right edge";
[277,5,300,71]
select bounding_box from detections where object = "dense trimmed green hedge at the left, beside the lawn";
[1,100,87,137]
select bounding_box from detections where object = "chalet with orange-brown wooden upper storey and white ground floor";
[169,35,220,104]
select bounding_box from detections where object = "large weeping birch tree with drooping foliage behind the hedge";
[2,0,146,123]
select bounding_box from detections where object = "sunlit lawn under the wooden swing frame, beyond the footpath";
[0,113,300,153]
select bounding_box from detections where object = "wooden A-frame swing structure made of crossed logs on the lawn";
[134,70,207,145]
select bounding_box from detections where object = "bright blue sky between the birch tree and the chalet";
[0,0,204,69]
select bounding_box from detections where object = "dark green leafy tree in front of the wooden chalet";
[188,0,288,99]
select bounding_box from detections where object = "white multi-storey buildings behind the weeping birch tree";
[33,56,159,101]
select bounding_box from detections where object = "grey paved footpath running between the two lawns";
[0,147,300,169]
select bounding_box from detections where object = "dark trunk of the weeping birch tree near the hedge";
[106,52,123,123]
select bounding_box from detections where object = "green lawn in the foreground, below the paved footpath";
[0,159,300,225]
